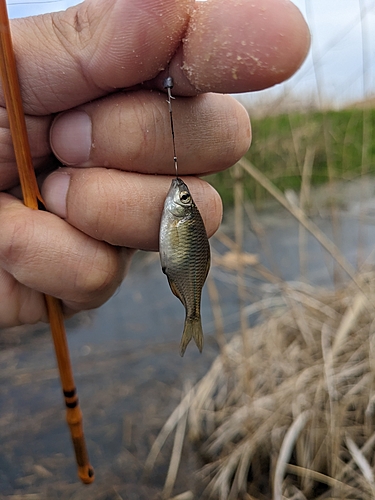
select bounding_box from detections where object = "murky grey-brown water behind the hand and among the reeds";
[0,197,375,500]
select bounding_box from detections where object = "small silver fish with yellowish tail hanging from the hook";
[159,177,211,356]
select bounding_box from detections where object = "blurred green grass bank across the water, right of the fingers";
[208,109,375,206]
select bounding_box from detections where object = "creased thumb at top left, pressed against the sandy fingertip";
[9,0,191,115]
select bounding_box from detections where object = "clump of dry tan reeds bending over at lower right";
[148,270,375,500]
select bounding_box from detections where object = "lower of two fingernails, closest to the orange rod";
[42,172,70,219]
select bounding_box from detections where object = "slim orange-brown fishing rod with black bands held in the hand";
[0,0,94,484]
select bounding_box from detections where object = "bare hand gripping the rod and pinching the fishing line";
[0,0,310,327]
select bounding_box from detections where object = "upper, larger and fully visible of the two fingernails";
[50,111,92,165]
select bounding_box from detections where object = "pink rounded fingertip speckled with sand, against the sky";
[182,0,310,92]
